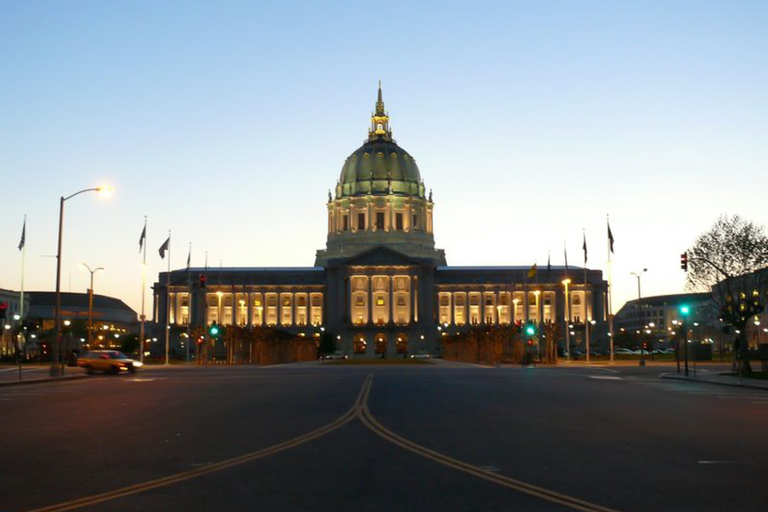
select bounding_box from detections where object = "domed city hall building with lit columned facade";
[153,88,608,357]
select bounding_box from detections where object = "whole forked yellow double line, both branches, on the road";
[32,374,617,512]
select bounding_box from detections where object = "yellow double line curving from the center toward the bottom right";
[357,375,617,512]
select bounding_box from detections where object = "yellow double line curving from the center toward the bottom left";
[31,375,372,512]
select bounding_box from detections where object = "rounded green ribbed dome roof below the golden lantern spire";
[337,139,424,197]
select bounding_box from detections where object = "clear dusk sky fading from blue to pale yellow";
[0,0,768,315]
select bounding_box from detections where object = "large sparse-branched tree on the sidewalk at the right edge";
[686,215,768,372]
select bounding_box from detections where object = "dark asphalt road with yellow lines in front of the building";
[0,362,768,512]
